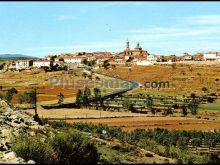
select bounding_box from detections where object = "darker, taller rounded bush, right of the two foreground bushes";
[51,129,99,164]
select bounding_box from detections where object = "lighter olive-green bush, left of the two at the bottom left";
[12,136,54,163]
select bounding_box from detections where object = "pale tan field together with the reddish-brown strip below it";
[26,107,220,131]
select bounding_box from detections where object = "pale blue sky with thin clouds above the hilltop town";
[0,1,220,57]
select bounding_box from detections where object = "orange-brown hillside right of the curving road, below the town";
[99,63,220,95]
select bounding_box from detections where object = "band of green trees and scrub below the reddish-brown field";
[46,122,220,163]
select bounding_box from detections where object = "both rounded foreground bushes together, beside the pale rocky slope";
[12,129,99,164]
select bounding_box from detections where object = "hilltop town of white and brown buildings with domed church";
[3,40,220,70]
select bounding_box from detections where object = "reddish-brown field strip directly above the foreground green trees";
[67,116,220,131]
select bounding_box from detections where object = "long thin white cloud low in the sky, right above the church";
[124,26,220,41]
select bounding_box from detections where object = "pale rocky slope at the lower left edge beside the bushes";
[0,100,50,164]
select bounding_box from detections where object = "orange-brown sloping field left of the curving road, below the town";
[0,69,124,104]
